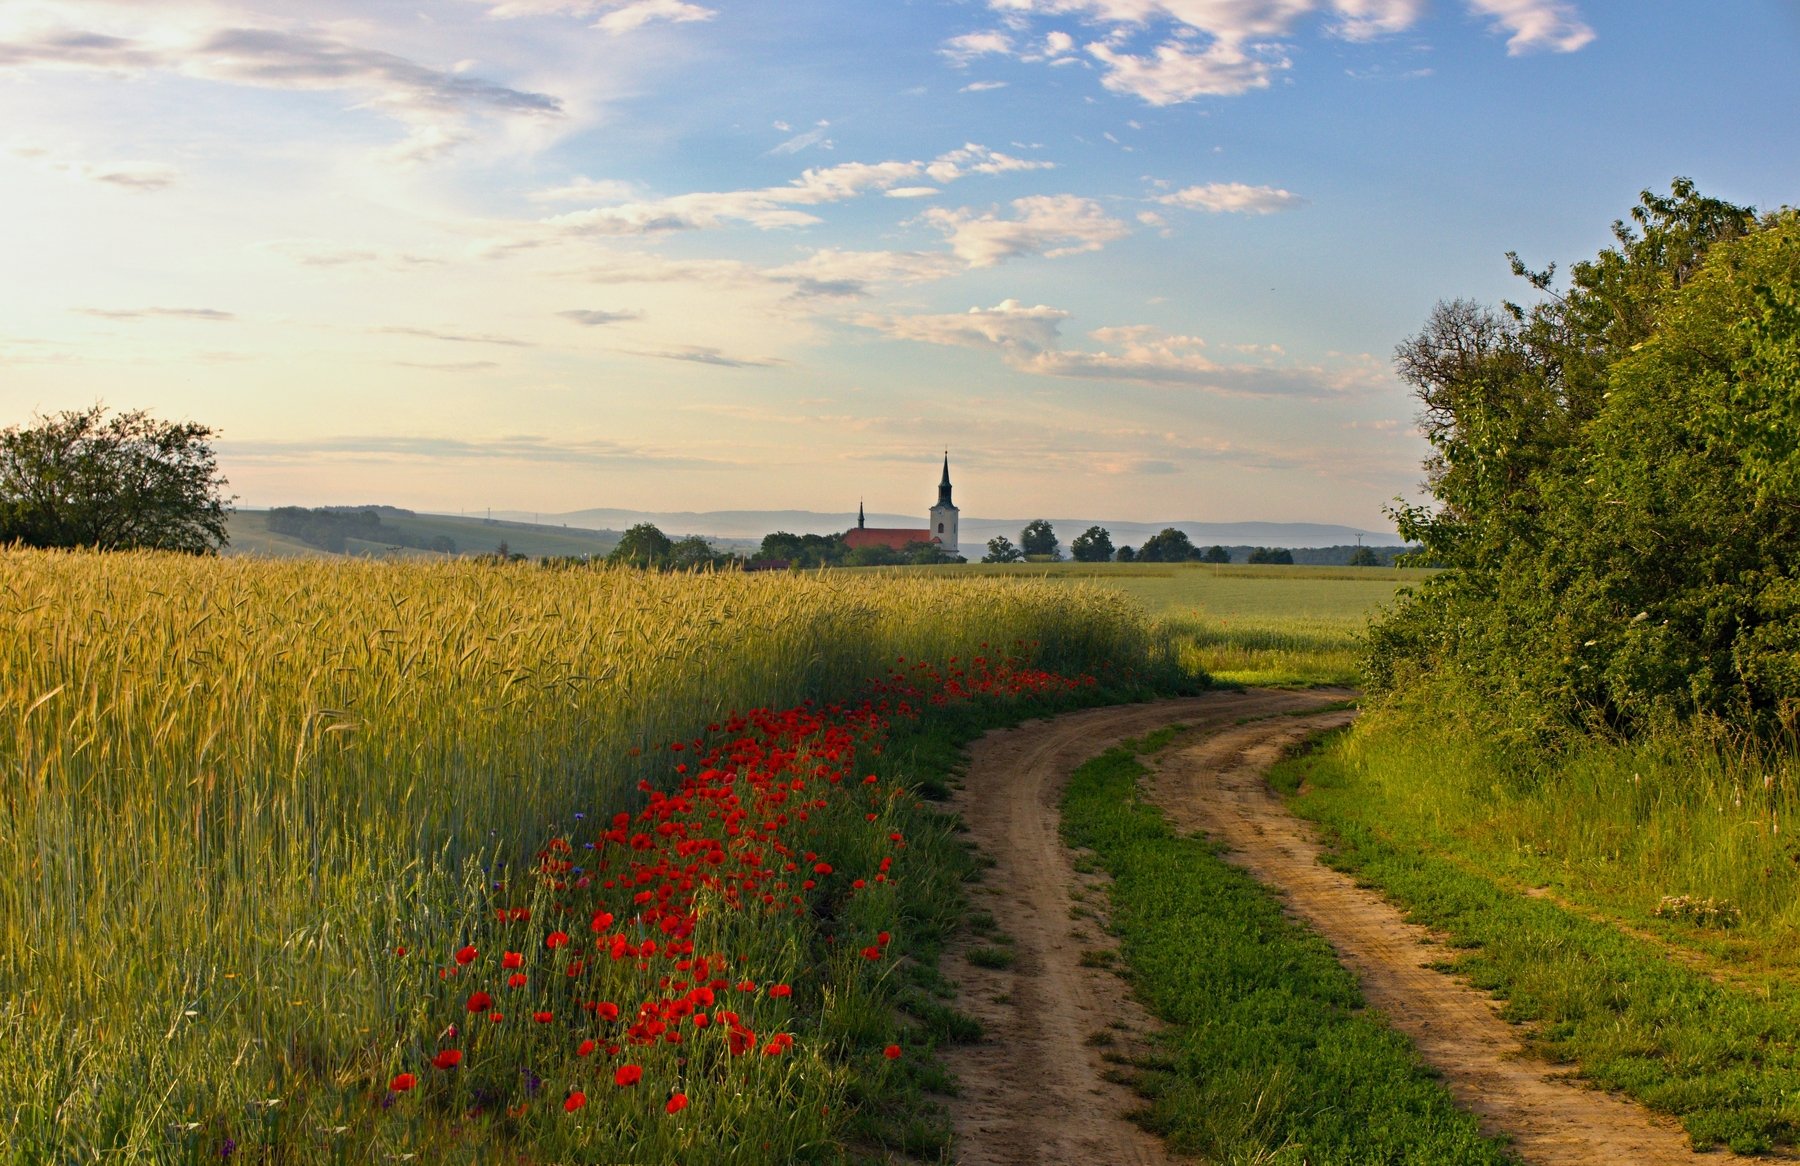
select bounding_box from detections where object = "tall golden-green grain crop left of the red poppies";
[0,552,1156,1161]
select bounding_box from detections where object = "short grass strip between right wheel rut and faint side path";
[1273,734,1800,1153]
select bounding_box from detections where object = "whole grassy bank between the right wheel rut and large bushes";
[1274,723,1800,1152]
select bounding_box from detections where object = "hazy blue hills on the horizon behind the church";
[506,509,1400,560]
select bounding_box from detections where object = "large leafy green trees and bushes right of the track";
[1370,180,1800,740]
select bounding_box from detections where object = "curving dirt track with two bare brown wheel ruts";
[947,689,1732,1166]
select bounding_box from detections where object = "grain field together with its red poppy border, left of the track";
[0,551,1170,1162]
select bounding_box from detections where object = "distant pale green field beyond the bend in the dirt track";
[909,563,1431,687]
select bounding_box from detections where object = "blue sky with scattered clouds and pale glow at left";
[0,0,1800,529]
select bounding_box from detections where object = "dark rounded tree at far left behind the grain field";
[0,405,230,554]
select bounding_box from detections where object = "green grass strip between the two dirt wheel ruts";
[1062,738,1512,1166]
